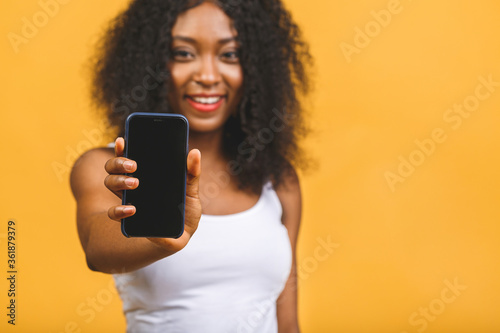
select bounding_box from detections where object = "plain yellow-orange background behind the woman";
[0,0,500,333]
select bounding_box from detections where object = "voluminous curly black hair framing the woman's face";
[92,0,312,193]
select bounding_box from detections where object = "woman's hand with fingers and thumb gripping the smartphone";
[104,138,201,252]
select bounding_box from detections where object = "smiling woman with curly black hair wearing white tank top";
[71,0,311,333]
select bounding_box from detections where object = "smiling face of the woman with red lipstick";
[168,2,243,132]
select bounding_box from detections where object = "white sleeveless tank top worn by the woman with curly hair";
[114,183,292,333]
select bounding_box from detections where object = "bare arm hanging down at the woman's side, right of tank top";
[276,172,302,333]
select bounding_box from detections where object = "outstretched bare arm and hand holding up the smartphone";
[70,139,201,273]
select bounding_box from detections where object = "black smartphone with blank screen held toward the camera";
[121,112,189,238]
